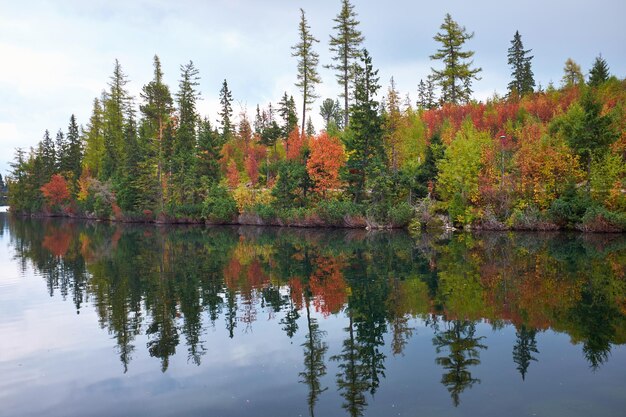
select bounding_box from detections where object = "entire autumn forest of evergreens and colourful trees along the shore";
[8,0,626,231]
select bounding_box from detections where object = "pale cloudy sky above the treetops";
[0,0,626,176]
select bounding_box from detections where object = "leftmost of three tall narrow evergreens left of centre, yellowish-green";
[102,59,129,179]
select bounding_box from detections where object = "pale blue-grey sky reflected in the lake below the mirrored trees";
[0,214,626,417]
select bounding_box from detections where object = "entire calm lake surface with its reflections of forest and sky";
[0,214,626,417]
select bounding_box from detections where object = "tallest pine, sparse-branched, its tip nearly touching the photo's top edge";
[327,0,365,127]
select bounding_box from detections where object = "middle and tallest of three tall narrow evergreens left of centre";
[139,55,174,211]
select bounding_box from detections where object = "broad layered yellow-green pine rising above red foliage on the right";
[430,14,482,104]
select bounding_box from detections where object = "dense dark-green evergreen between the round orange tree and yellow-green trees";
[344,50,384,203]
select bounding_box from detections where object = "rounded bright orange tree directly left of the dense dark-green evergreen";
[306,132,346,195]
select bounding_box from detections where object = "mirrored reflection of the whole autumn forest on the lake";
[6,217,626,416]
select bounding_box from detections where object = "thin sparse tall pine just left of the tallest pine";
[291,9,322,135]
